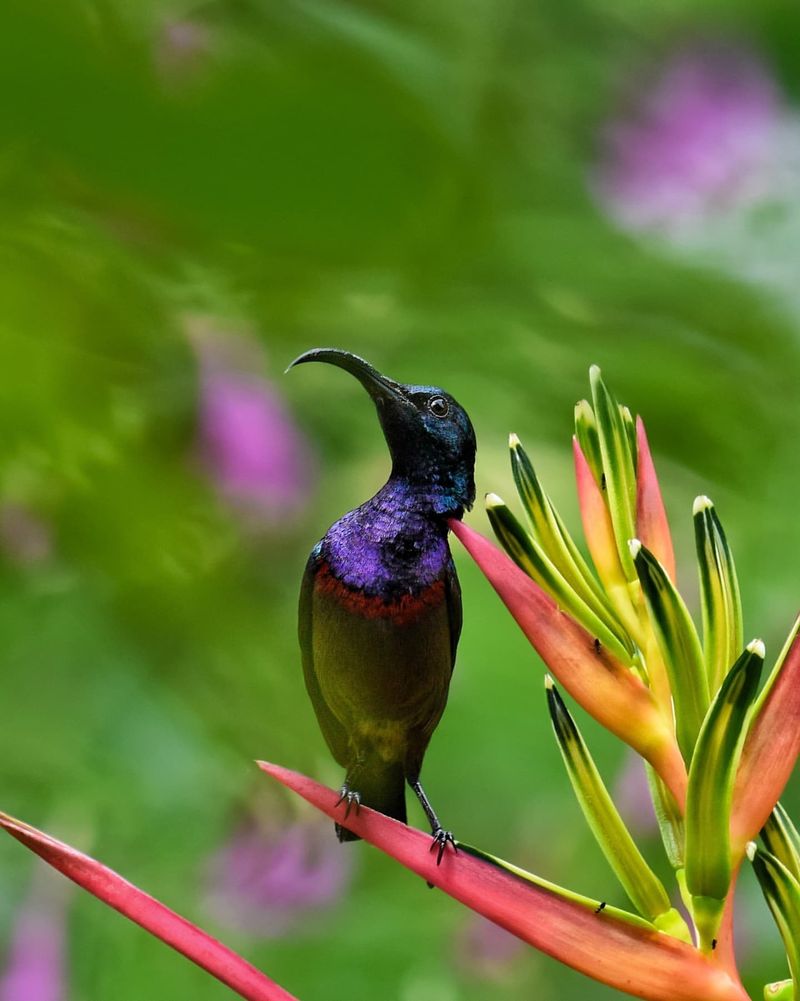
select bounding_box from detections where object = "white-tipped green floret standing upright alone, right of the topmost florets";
[693,496,744,692]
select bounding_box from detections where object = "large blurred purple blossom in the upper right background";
[593,41,785,233]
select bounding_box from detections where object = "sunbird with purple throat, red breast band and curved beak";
[286,347,476,864]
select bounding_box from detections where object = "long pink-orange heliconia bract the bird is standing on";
[259,762,747,1001]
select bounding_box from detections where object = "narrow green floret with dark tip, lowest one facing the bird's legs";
[545,676,691,942]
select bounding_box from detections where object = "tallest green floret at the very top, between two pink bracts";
[589,365,636,581]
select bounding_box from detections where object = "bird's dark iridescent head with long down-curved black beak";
[289,347,476,517]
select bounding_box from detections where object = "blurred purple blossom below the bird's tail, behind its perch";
[209,817,353,938]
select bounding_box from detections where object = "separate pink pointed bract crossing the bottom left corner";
[0,813,296,1001]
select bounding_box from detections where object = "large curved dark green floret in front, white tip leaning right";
[686,640,764,950]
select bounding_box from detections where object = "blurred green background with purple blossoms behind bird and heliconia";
[0,0,800,1001]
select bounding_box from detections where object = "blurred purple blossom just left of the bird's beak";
[189,321,313,528]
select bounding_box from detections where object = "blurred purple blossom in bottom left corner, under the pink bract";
[0,863,71,1001]
